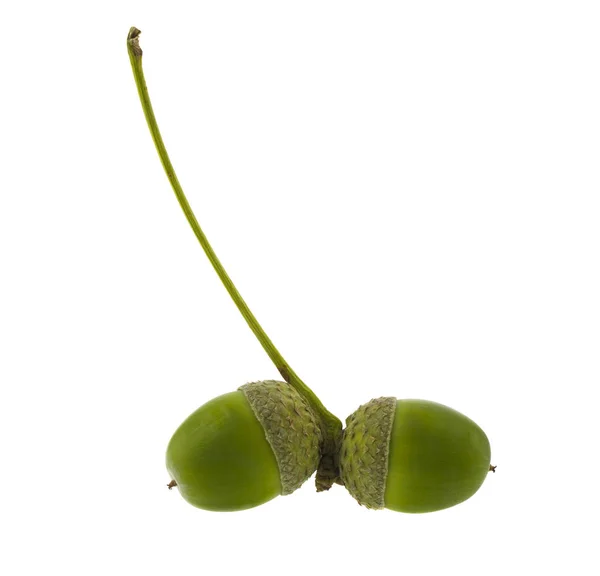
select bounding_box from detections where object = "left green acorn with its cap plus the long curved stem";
[127,28,342,511]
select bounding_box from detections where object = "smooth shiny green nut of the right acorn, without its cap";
[385,400,490,513]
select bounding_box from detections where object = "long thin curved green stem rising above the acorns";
[127,27,342,476]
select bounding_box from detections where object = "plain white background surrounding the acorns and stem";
[0,0,600,576]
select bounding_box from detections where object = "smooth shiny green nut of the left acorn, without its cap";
[167,391,281,512]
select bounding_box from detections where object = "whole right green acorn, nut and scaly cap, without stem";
[340,398,490,513]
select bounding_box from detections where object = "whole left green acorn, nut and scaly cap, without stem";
[166,380,321,512]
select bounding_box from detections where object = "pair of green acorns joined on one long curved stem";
[127,28,494,513]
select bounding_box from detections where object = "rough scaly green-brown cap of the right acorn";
[340,397,396,510]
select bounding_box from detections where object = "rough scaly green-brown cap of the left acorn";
[239,380,322,495]
